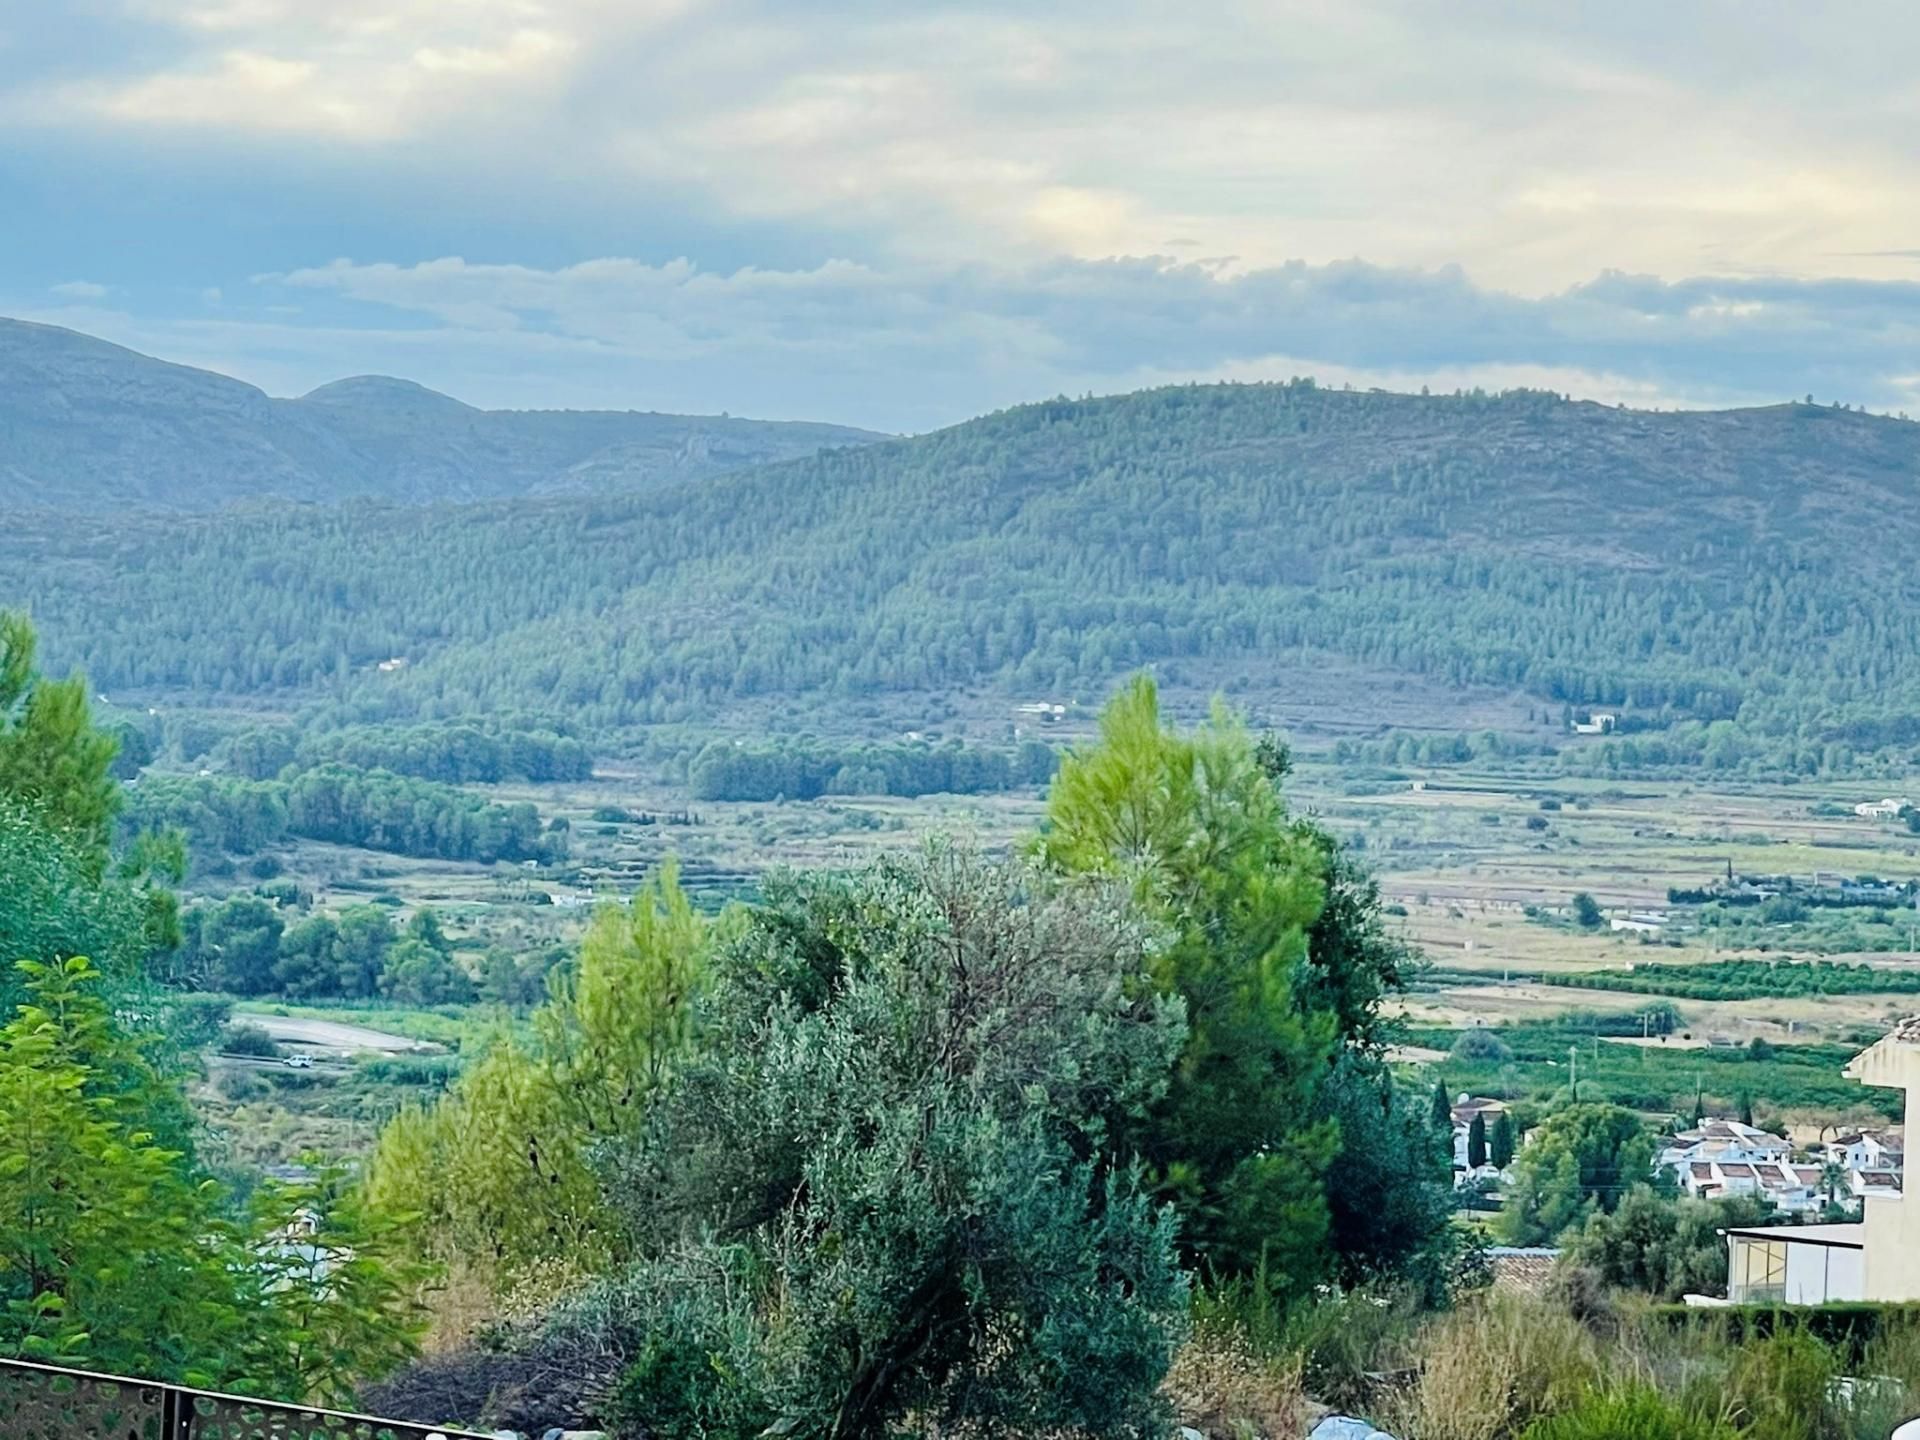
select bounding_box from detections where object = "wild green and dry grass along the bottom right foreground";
[1177,1284,1920,1440]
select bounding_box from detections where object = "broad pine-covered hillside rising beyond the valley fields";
[11,382,1920,762]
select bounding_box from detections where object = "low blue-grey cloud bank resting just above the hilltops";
[236,257,1920,428]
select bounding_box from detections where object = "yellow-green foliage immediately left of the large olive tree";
[369,868,708,1288]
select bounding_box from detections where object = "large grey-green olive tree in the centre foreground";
[603,849,1187,1436]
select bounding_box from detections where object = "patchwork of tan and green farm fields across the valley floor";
[165,737,1920,1164]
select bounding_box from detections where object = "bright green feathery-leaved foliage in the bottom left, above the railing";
[0,958,419,1400]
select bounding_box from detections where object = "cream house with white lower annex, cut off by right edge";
[1726,1016,1920,1306]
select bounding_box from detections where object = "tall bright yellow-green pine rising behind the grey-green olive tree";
[1041,676,1338,1294]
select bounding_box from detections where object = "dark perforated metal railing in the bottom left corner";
[0,1359,486,1440]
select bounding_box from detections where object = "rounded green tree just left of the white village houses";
[1498,1104,1653,1244]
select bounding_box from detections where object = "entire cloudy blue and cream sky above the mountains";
[0,0,1920,432]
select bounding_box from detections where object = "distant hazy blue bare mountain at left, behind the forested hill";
[0,319,877,511]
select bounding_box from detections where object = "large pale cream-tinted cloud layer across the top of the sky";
[11,0,1920,296]
